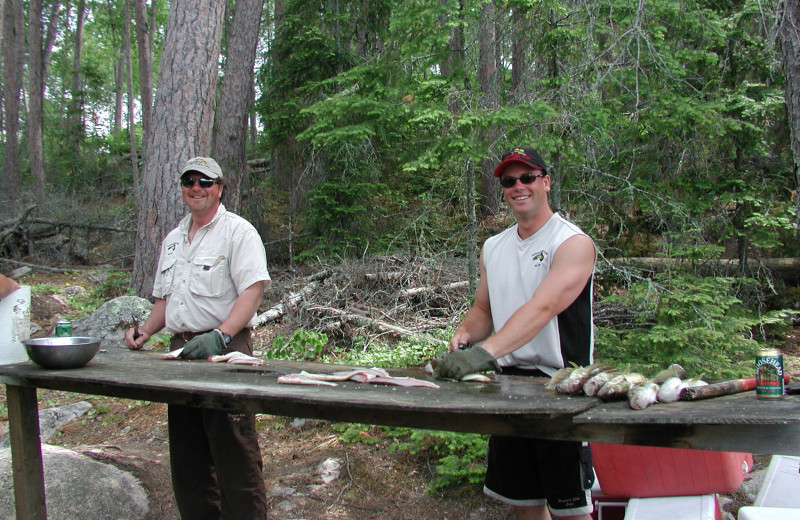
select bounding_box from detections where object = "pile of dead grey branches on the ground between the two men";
[258,256,471,346]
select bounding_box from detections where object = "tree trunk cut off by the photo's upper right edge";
[776,0,800,234]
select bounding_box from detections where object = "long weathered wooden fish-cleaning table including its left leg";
[0,347,800,520]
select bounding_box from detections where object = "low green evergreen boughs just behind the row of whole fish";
[596,273,779,379]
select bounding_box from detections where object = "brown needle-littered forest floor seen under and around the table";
[0,264,800,520]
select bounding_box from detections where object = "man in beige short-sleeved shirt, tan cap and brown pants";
[125,157,270,520]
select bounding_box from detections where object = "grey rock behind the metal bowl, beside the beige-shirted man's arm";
[72,296,153,348]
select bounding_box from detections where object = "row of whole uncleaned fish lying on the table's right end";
[545,363,708,410]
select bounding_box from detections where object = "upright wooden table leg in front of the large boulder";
[6,385,47,520]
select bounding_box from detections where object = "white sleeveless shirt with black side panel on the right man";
[483,213,594,375]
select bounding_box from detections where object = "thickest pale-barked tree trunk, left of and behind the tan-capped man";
[131,0,225,297]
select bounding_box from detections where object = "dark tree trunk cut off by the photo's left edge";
[2,0,25,202]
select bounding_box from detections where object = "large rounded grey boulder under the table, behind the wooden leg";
[0,444,149,520]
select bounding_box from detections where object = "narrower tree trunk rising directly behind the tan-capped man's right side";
[214,0,264,213]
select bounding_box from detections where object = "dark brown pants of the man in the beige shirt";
[167,329,267,520]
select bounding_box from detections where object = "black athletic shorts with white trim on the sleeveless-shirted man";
[483,435,594,516]
